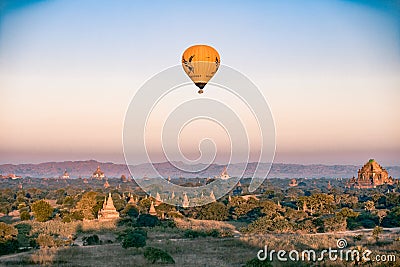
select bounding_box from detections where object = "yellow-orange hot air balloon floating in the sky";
[182,45,221,94]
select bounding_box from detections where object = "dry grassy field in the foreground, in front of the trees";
[0,220,400,267]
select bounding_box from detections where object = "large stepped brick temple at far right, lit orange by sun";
[350,159,394,189]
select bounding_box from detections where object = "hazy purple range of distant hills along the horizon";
[0,160,400,178]
